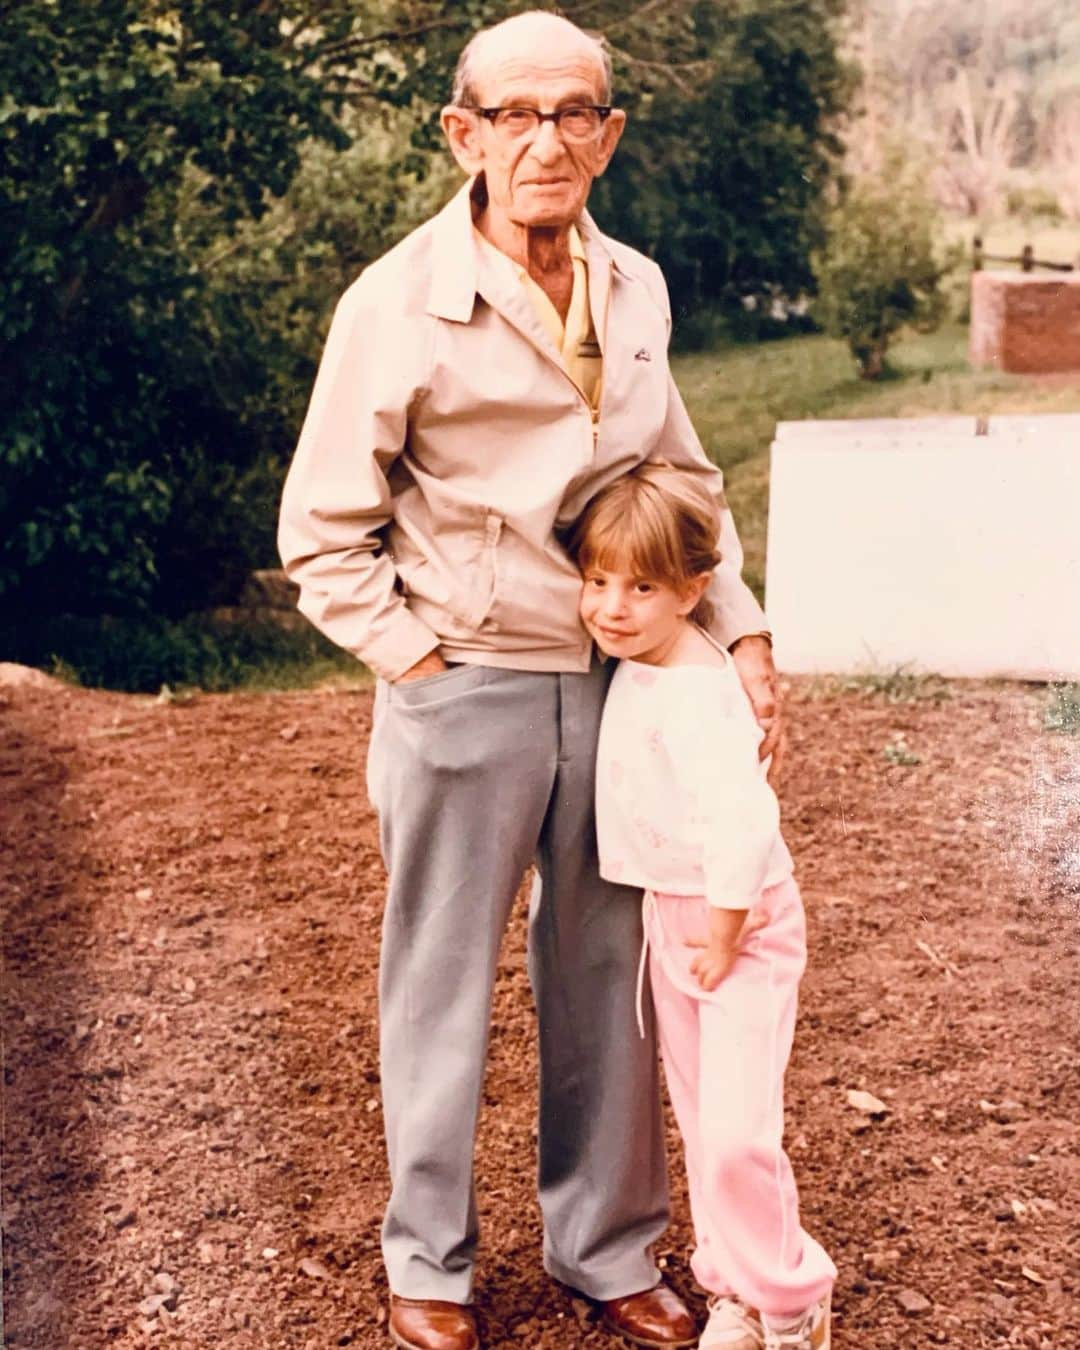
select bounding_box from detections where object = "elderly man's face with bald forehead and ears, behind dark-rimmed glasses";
[444,31,624,228]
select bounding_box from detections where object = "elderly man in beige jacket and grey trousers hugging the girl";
[281,12,779,1350]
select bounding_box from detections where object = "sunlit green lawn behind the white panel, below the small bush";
[671,324,1080,599]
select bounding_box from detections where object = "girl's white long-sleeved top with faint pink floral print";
[597,652,792,910]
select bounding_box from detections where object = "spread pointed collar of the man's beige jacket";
[428,178,626,332]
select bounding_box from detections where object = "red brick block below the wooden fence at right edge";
[971,271,1080,374]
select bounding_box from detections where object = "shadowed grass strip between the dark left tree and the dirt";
[0,616,370,694]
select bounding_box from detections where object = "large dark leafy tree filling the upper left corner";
[0,0,491,613]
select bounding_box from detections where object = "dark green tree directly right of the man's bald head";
[570,0,853,325]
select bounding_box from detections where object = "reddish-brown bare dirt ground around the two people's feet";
[0,678,1080,1350]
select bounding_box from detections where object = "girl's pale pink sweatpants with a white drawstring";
[645,879,836,1316]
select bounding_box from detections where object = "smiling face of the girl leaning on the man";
[581,566,707,666]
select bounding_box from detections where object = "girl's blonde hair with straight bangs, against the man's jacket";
[567,464,720,626]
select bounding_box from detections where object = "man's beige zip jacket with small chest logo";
[278,185,765,679]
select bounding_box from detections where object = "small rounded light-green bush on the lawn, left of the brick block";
[814,157,959,379]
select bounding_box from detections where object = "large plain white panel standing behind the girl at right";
[765,414,1080,679]
